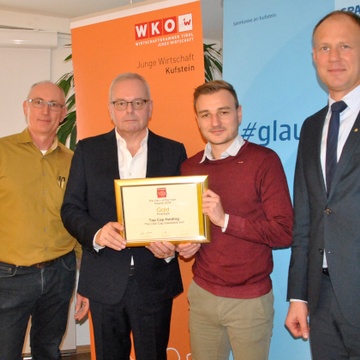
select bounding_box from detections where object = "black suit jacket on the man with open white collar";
[61,130,186,304]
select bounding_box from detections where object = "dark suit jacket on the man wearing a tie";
[288,107,360,326]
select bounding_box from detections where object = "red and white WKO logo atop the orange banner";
[135,14,193,40]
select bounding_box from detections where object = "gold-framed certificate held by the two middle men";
[114,175,210,246]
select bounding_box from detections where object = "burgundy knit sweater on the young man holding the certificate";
[181,141,293,299]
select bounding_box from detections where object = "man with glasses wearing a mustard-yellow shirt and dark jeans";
[0,81,76,360]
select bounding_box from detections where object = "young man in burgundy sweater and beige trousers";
[178,81,293,360]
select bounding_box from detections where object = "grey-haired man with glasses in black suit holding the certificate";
[61,73,186,360]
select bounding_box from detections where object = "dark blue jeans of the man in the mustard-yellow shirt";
[0,251,76,360]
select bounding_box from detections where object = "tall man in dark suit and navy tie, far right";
[286,11,360,360]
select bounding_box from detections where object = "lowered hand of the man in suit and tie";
[285,301,310,340]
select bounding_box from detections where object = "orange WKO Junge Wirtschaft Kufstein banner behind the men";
[71,0,204,360]
